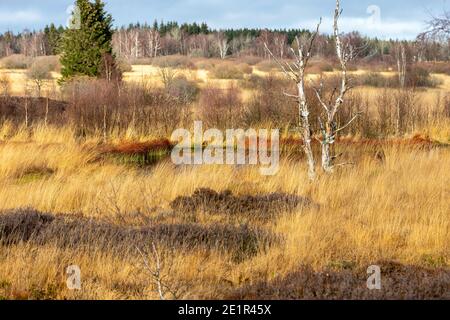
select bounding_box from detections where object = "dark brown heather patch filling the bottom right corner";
[226,262,450,300]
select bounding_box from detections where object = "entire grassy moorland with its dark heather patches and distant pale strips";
[0,60,450,299]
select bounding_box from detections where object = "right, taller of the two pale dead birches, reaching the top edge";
[314,0,360,173]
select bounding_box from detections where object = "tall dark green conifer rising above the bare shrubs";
[60,0,117,82]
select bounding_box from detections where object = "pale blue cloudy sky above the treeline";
[0,0,450,39]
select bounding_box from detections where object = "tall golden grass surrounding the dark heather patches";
[0,121,450,299]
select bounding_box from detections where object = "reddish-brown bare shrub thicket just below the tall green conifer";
[64,79,189,137]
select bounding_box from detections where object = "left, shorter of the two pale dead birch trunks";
[264,19,322,180]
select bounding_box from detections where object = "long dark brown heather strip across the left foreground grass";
[0,209,278,260]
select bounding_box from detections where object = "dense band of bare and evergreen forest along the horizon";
[0,21,450,62]
